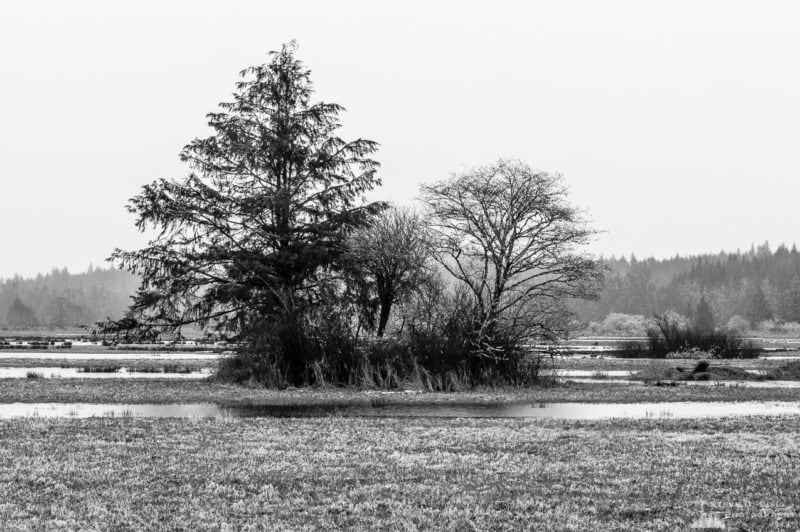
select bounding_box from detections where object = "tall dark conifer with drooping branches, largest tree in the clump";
[112,43,382,380]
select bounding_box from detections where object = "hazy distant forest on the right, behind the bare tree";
[573,243,800,328]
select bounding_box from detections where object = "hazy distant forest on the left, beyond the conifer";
[0,266,139,329]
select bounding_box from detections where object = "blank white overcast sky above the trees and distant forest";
[0,0,800,277]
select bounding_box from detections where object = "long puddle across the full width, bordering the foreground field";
[0,401,800,419]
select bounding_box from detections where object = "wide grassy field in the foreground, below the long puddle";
[0,417,800,530]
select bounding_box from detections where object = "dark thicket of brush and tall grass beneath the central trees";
[217,282,546,391]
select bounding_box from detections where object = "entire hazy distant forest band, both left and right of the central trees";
[6,243,800,329]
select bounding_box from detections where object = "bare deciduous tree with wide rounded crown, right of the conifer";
[422,160,602,348]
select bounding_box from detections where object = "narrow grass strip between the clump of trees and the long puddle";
[0,379,800,405]
